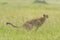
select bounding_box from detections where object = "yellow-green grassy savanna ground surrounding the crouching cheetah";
[0,0,60,40]
